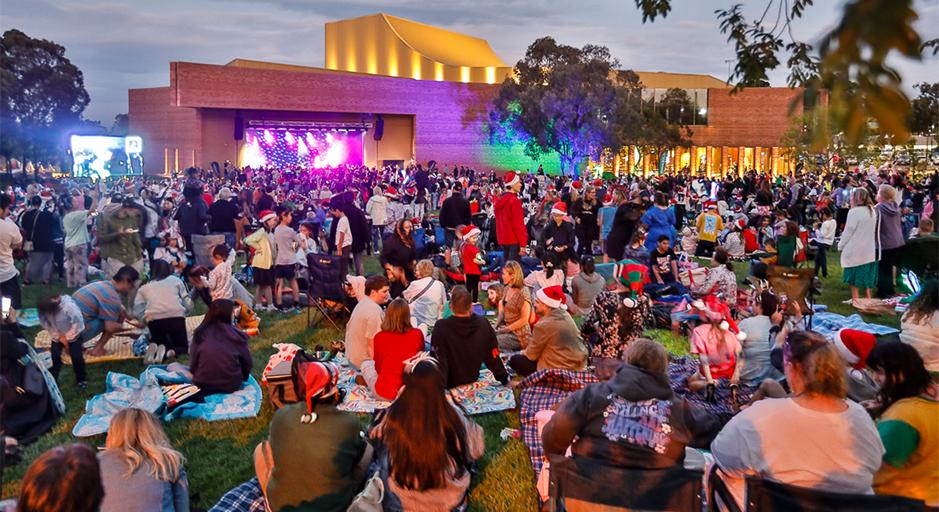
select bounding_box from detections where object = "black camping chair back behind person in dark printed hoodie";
[547,455,704,512]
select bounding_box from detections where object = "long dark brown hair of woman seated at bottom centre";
[381,361,471,492]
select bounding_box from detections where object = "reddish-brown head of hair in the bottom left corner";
[16,444,104,512]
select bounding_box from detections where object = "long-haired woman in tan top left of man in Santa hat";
[496,261,532,351]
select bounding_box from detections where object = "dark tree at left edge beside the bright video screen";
[0,29,89,161]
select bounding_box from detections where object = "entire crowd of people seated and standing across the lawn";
[0,162,939,511]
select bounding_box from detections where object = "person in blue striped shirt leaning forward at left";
[72,265,143,356]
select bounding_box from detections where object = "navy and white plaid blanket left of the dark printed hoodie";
[517,369,600,475]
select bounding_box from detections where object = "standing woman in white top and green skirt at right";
[838,188,880,303]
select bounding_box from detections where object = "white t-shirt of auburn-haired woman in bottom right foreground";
[711,398,884,504]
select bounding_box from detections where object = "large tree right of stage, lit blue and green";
[489,37,635,174]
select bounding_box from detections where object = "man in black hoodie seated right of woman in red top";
[430,286,509,388]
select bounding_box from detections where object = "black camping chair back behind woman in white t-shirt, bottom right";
[708,465,930,512]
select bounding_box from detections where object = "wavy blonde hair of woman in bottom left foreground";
[105,408,185,482]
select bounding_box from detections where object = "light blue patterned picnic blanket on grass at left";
[72,365,261,437]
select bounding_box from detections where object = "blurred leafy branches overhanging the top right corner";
[634,0,939,144]
